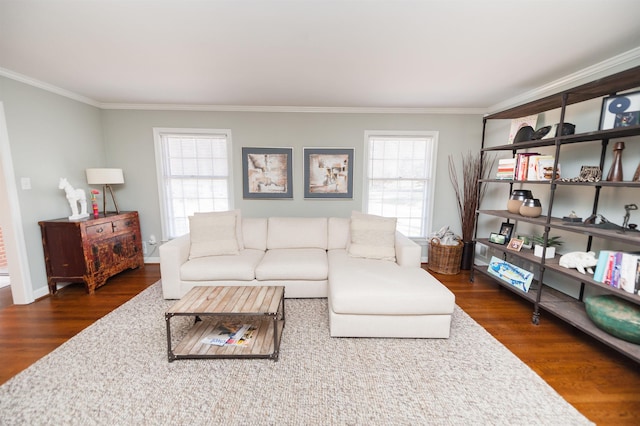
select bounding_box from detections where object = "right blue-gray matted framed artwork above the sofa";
[303,148,354,198]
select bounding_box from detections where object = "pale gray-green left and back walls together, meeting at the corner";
[0,77,482,296]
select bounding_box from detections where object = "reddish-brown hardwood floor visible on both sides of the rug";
[0,265,640,425]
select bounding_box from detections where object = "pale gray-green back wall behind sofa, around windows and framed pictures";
[102,110,482,248]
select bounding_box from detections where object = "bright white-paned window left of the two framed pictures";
[154,129,233,240]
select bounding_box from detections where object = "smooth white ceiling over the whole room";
[0,0,640,109]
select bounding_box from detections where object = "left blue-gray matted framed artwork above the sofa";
[242,147,293,199]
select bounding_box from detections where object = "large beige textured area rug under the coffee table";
[0,283,590,425]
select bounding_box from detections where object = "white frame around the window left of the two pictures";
[153,127,235,241]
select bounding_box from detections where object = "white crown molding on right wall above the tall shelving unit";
[488,47,640,114]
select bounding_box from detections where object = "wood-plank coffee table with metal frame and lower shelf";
[165,286,285,362]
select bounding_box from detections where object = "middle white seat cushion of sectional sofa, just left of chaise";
[256,248,329,281]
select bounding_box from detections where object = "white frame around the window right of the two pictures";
[362,130,439,241]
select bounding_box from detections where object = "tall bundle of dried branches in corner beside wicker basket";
[449,151,495,269]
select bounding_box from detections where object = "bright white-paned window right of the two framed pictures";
[363,132,438,238]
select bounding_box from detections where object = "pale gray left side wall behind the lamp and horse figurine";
[0,77,105,296]
